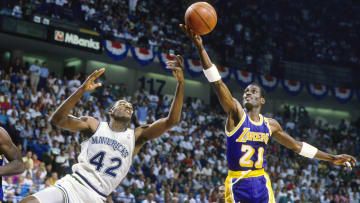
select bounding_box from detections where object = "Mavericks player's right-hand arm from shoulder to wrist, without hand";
[134,82,184,155]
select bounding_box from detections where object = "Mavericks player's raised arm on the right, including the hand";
[135,55,184,152]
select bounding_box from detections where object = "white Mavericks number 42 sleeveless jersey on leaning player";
[72,122,135,198]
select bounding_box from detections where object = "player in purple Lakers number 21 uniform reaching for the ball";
[180,25,356,203]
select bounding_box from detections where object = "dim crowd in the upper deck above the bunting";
[0,0,360,73]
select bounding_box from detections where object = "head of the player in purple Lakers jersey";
[243,85,265,108]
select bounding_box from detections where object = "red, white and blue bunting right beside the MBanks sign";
[104,40,129,61]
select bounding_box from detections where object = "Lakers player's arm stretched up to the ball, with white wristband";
[180,24,243,118]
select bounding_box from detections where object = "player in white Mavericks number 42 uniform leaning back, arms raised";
[21,56,184,203]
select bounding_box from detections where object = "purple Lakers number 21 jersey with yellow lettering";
[225,110,271,171]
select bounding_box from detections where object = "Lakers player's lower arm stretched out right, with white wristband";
[269,119,356,169]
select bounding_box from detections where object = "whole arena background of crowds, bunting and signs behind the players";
[0,0,360,203]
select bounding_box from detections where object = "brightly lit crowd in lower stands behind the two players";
[0,58,360,203]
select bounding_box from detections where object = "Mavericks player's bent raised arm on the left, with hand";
[50,68,105,132]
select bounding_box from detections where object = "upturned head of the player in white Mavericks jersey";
[110,100,134,121]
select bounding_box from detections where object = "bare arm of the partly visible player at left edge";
[0,127,25,176]
